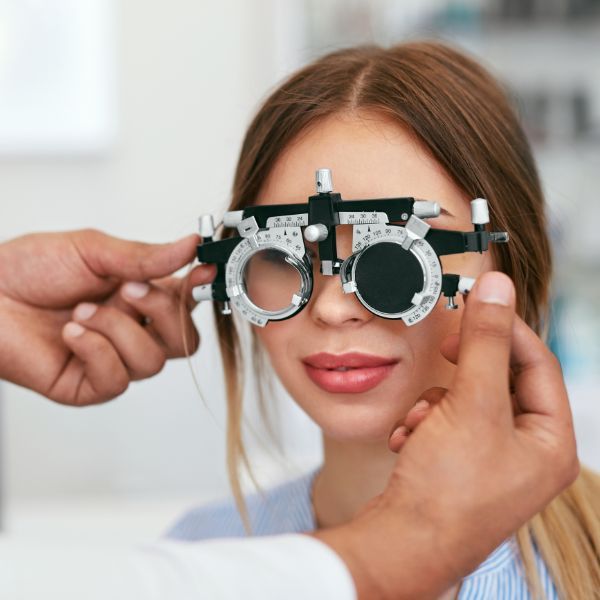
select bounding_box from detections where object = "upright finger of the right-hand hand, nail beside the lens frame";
[452,272,515,408]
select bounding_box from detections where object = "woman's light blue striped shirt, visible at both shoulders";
[166,471,558,600]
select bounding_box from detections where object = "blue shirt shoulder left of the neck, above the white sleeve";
[166,471,316,541]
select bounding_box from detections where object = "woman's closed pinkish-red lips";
[302,352,398,394]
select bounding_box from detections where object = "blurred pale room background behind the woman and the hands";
[0,0,600,552]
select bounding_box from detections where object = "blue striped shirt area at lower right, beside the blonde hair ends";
[458,538,558,600]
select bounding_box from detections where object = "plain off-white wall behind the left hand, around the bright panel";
[0,0,324,501]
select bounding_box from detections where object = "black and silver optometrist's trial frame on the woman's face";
[193,169,509,326]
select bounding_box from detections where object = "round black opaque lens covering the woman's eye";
[355,242,425,314]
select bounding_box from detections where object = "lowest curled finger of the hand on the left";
[59,321,129,406]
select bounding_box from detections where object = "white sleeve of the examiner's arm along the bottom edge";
[0,535,356,600]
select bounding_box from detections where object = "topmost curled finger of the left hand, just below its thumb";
[120,281,200,358]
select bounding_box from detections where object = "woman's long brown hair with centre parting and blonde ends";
[215,42,600,600]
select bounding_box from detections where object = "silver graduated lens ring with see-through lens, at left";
[225,227,313,327]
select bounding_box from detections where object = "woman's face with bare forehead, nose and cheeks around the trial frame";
[255,114,493,442]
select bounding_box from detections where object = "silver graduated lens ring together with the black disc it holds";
[340,224,442,325]
